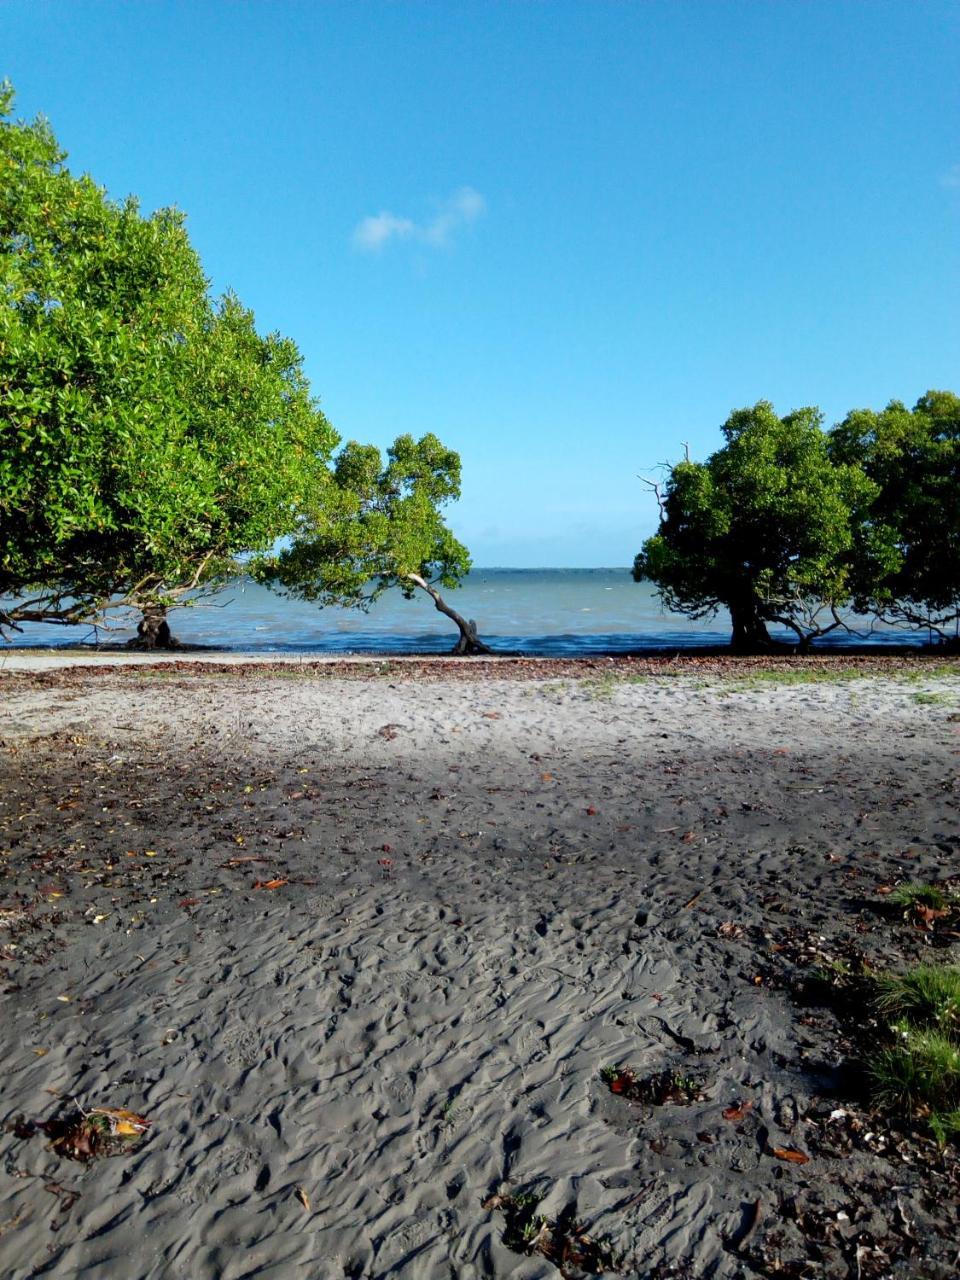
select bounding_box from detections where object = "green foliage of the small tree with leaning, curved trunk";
[255,434,470,608]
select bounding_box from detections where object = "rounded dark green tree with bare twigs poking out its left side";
[634,401,873,650]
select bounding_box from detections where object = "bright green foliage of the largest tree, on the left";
[0,86,337,625]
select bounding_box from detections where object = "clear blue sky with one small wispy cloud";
[0,0,960,566]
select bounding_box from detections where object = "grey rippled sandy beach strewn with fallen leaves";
[0,658,960,1280]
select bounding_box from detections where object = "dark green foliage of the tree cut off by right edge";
[829,390,960,635]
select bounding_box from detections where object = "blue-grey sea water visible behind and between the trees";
[5,568,924,655]
